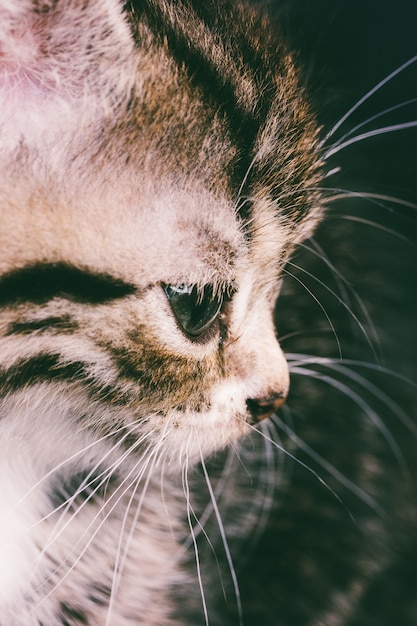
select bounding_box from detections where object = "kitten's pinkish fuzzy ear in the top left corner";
[0,0,133,105]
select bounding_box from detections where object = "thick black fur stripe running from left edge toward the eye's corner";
[0,263,136,306]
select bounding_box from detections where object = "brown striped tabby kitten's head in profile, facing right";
[0,0,321,461]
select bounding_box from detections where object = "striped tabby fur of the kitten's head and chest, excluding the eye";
[0,0,321,626]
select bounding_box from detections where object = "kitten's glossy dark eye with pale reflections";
[164,285,223,337]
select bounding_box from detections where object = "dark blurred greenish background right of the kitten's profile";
[210,0,417,626]
